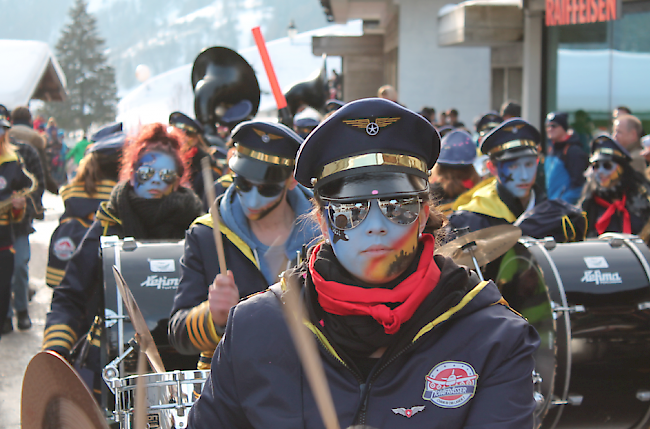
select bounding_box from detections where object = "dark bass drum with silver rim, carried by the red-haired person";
[101,236,198,377]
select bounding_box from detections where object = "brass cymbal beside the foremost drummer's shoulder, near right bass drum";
[436,225,521,267]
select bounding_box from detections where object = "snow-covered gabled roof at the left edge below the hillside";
[0,40,66,110]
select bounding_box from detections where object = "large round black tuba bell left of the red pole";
[192,46,260,135]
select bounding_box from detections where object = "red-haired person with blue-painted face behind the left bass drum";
[43,123,203,389]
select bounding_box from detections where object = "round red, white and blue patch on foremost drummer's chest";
[422,361,478,408]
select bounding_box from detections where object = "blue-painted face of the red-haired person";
[131,152,177,199]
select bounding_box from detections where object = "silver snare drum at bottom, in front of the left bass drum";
[112,370,210,429]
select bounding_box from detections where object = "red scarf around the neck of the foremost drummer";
[309,234,440,335]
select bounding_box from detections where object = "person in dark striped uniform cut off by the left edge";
[0,117,35,335]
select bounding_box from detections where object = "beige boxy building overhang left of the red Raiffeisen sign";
[438,0,524,46]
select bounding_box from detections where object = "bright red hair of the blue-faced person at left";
[120,122,190,185]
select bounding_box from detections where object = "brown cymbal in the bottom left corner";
[20,351,108,429]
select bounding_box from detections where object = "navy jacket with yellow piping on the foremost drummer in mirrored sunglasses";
[188,257,539,429]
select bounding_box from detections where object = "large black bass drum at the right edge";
[484,234,650,429]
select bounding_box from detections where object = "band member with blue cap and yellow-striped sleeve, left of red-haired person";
[46,123,126,287]
